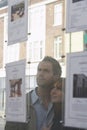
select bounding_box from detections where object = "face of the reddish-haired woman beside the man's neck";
[50,81,63,103]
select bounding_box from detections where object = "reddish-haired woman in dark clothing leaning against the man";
[43,78,79,130]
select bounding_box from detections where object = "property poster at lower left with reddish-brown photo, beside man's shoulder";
[6,60,26,122]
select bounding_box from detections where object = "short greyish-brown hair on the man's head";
[42,56,62,76]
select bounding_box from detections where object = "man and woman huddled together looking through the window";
[5,56,78,130]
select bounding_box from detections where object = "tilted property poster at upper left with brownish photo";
[8,0,28,45]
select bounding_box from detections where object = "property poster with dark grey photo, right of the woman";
[64,51,87,129]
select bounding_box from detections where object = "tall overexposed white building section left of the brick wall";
[26,5,46,62]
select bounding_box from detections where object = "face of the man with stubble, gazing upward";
[37,61,55,88]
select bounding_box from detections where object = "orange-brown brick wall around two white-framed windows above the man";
[45,2,64,56]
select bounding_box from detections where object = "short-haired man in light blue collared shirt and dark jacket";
[5,56,61,130]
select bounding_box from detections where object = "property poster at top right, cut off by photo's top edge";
[66,0,87,32]
